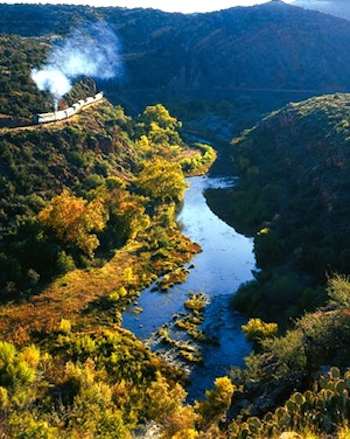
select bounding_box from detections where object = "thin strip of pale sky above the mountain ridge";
[0,0,296,12]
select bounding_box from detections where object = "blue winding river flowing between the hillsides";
[124,176,255,400]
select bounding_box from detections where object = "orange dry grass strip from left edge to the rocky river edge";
[0,229,199,344]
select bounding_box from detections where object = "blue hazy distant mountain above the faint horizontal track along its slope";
[0,1,350,93]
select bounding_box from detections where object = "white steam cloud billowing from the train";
[31,22,122,106]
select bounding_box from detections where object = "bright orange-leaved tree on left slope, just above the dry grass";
[38,190,107,257]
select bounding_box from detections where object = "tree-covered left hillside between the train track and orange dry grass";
[0,96,215,296]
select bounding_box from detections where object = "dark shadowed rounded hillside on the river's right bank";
[208,94,350,318]
